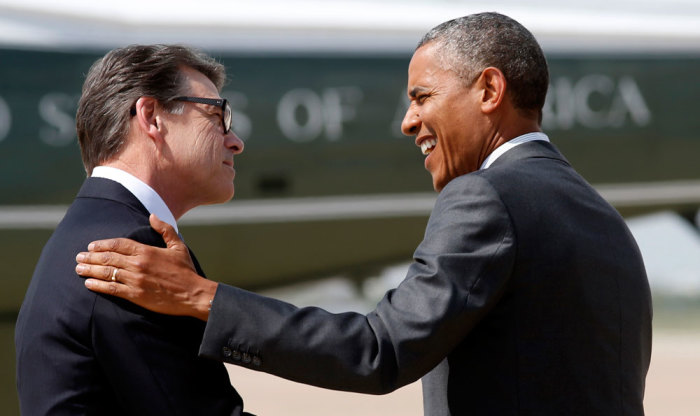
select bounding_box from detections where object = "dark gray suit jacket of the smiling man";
[200,141,651,416]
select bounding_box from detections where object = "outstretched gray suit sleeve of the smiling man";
[200,175,515,394]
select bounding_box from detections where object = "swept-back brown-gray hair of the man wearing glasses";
[75,45,226,175]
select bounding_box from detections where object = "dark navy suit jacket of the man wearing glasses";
[15,178,249,416]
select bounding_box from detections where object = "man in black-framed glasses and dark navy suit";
[15,45,252,415]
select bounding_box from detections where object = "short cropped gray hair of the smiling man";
[416,13,549,120]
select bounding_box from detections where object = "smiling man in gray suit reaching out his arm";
[78,13,651,416]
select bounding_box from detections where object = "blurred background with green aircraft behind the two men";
[0,0,700,416]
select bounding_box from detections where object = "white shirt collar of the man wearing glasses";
[91,166,179,232]
